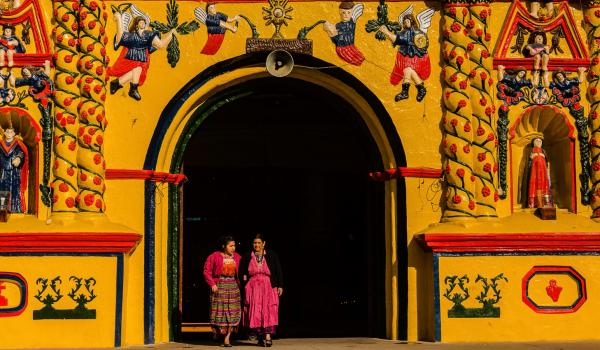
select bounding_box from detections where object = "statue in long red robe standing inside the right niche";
[525,137,554,208]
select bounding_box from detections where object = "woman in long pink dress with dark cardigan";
[239,234,283,347]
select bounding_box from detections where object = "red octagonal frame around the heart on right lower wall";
[521,266,587,314]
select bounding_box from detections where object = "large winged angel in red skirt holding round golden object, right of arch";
[379,5,435,102]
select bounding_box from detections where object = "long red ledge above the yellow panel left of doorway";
[0,232,142,253]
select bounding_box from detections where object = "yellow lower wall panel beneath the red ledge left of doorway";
[0,256,117,348]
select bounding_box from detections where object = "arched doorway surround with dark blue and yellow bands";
[144,54,408,343]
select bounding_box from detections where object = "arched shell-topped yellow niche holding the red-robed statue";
[510,106,577,212]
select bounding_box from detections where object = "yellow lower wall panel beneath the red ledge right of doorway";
[438,256,600,342]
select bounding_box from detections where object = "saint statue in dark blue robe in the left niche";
[0,126,29,213]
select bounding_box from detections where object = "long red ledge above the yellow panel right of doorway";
[416,232,600,253]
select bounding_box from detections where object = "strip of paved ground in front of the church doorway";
[126,338,600,350]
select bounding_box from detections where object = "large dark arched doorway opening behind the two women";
[180,78,386,337]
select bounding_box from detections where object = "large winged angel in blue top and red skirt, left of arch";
[107,5,175,101]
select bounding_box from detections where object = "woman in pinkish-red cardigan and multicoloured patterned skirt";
[204,236,242,347]
